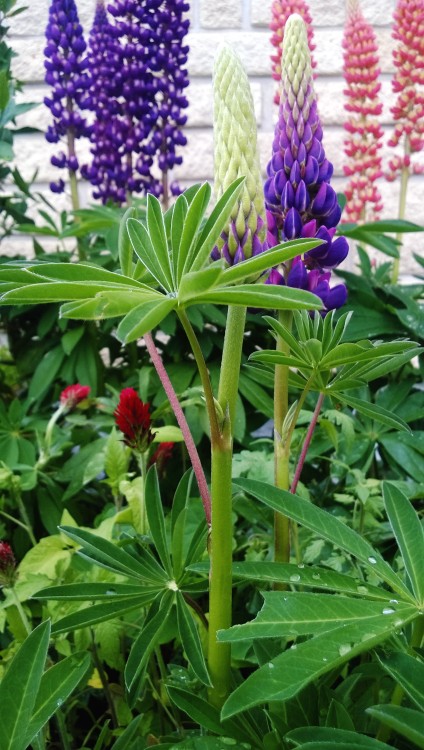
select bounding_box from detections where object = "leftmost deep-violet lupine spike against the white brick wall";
[44,0,90,193]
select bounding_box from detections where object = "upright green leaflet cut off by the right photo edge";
[383,482,424,606]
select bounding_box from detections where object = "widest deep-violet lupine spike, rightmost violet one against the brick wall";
[100,0,189,202]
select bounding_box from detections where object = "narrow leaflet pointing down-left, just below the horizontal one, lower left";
[52,588,161,635]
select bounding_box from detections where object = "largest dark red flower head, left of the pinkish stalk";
[113,388,154,453]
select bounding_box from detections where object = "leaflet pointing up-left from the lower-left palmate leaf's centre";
[59,526,167,585]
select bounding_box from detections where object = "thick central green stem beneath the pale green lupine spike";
[208,306,246,708]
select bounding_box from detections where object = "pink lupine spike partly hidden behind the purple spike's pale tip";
[270,0,316,104]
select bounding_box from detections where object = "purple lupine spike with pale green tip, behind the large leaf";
[265,14,349,310]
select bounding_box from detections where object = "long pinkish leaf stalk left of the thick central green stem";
[144,333,211,526]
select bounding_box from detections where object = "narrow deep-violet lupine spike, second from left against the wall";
[81,0,128,204]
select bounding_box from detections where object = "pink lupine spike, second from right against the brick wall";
[343,0,383,222]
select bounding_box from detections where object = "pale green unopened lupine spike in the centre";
[212,44,268,265]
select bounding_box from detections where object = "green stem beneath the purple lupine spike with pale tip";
[274,310,293,562]
